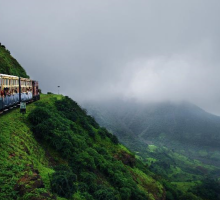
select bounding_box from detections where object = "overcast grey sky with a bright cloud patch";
[0,0,220,115]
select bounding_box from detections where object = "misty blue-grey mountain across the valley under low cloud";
[84,101,220,166]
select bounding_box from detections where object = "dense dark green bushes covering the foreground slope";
[28,97,165,200]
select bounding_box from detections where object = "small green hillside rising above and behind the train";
[0,43,28,78]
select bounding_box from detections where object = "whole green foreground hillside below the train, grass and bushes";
[0,95,187,200]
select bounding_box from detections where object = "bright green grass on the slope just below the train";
[0,95,62,199]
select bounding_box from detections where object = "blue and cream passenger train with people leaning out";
[0,74,40,112]
